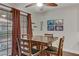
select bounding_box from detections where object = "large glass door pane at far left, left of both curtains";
[0,9,12,56]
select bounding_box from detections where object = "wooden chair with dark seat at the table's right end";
[43,36,64,56]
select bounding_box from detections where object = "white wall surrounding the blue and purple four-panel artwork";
[32,7,79,53]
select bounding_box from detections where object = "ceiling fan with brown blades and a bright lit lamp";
[25,3,58,8]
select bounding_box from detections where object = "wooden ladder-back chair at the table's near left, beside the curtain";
[17,34,40,56]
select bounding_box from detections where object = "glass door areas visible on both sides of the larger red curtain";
[0,8,27,56]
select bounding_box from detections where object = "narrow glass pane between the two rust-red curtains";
[20,15,27,38]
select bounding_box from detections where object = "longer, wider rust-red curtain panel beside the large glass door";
[12,8,20,56]
